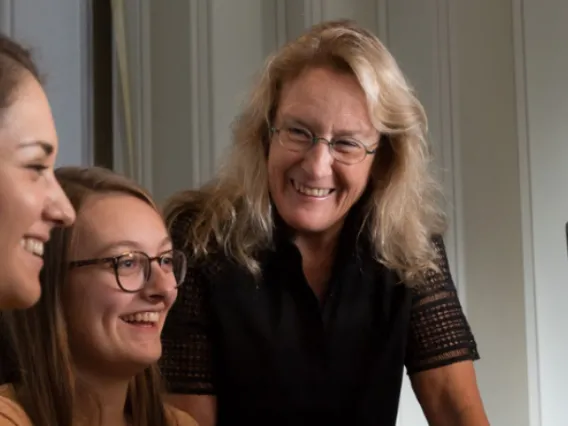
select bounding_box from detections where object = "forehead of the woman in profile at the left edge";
[0,71,57,154]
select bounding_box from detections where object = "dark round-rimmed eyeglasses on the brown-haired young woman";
[69,250,187,293]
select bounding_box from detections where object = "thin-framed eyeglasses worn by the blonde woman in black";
[270,127,377,164]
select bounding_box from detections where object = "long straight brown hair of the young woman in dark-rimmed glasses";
[5,167,175,426]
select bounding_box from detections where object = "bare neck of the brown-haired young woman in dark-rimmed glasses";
[75,374,129,426]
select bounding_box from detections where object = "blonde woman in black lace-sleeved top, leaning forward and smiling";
[162,21,488,426]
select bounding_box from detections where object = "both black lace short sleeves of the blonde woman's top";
[160,211,479,394]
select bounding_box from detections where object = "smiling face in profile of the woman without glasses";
[0,71,75,309]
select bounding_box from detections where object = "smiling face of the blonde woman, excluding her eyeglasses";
[268,68,379,238]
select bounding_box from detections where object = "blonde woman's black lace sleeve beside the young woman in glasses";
[160,211,214,395]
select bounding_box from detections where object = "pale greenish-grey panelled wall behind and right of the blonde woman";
[121,0,568,426]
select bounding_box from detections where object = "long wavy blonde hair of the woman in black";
[166,20,445,283]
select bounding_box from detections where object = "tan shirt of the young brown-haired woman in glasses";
[0,385,199,426]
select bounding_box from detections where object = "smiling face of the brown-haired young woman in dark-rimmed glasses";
[64,194,177,376]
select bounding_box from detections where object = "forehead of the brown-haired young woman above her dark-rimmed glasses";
[73,193,168,256]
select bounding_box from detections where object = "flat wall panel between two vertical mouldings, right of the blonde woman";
[452,0,529,425]
